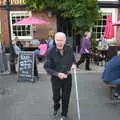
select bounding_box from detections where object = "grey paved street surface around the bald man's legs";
[0,65,120,120]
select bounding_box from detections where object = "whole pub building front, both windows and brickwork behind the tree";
[0,0,120,46]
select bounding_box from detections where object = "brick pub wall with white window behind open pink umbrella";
[0,0,57,46]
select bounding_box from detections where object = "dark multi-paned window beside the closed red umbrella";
[92,13,111,40]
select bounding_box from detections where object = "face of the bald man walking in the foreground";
[55,35,66,50]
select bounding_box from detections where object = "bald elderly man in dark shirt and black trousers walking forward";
[44,32,75,120]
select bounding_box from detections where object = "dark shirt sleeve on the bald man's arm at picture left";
[44,50,58,76]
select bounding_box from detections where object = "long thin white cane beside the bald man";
[73,68,80,120]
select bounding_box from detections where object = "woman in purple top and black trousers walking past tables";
[76,32,91,70]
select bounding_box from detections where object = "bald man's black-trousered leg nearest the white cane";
[61,75,72,117]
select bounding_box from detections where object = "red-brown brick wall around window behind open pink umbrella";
[0,6,57,46]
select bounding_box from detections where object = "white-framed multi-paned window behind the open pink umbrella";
[10,11,33,40]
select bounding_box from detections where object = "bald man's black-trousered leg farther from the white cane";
[51,77,61,114]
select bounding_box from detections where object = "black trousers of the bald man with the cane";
[51,74,72,116]
